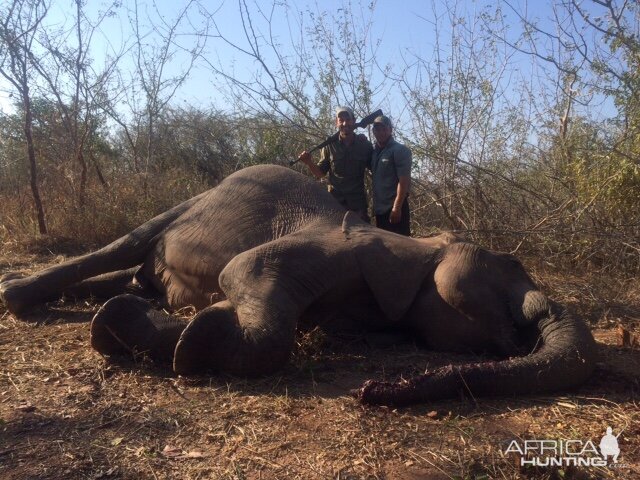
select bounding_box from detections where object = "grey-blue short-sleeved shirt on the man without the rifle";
[369,138,411,215]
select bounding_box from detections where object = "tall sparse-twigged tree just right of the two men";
[399,2,540,240]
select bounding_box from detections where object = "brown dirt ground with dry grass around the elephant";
[0,252,640,479]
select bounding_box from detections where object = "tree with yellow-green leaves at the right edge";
[500,0,640,268]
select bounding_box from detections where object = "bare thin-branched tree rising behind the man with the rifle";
[202,0,390,143]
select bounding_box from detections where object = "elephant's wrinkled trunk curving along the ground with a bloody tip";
[352,302,597,406]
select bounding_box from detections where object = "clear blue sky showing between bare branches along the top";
[0,0,620,124]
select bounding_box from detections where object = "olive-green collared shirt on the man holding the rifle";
[318,134,373,211]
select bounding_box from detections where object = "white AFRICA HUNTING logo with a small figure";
[504,427,622,467]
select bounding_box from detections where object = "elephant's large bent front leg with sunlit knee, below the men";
[174,219,365,376]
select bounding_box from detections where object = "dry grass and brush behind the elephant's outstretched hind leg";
[0,169,211,254]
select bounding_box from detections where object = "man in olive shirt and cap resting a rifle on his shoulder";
[298,107,373,222]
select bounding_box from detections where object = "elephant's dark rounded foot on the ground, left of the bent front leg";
[91,294,186,361]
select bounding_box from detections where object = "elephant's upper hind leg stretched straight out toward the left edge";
[0,192,206,314]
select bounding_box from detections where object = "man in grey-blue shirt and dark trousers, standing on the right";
[369,115,411,236]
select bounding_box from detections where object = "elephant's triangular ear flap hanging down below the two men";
[342,212,438,321]
